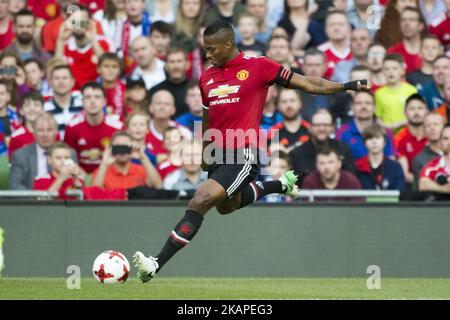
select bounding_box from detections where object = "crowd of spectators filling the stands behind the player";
[0,0,450,202]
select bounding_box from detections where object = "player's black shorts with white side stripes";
[208,148,260,198]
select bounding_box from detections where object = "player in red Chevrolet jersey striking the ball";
[133,21,368,282]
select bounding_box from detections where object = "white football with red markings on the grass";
[92,250,130,284]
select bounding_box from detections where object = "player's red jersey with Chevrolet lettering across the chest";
[199,53,282,149]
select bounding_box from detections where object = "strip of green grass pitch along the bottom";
[0,277,450,300]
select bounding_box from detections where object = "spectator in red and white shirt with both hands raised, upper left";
[55,6,109,89]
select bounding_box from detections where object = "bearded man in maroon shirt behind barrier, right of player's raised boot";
[302,148,361,200]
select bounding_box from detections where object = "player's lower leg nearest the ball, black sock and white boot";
[133,179,227,282]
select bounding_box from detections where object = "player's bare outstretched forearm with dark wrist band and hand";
[289,73,369,95]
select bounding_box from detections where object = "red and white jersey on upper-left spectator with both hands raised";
[64,36,109,90]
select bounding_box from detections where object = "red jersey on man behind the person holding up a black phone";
[64,115,123,173]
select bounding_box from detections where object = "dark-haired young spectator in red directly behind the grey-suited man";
[8,91,45,159]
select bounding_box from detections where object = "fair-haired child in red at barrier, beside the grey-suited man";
[33,142,84,199]
